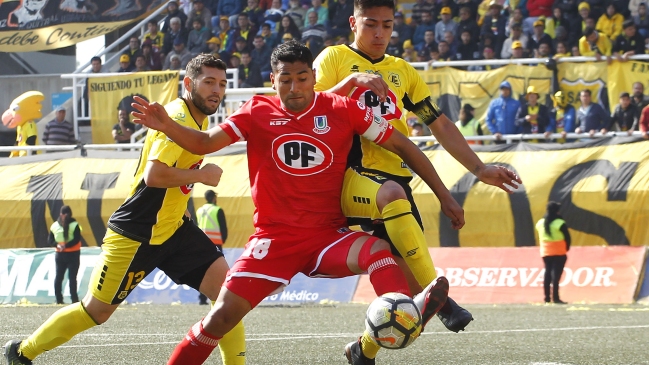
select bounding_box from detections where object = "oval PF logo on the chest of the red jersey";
[272,133,334,176]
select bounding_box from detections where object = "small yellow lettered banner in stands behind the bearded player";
[88,71,178,143]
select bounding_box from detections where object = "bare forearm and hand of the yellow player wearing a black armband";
[428,114,523,193]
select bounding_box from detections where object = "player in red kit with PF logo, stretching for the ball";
[134,41,464,365]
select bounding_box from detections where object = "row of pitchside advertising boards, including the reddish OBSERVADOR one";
[0,247,649,305]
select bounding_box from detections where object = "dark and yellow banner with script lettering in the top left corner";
[0,0,166,52]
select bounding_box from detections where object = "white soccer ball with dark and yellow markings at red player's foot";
[365,293,421,349]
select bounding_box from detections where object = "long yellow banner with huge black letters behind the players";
[0,141,649,248]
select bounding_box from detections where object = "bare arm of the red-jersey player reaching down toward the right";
[381,129,464,229]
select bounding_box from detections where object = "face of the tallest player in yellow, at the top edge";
[349,6,394,58]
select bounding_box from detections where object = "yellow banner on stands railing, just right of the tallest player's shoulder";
[419,65,552,122]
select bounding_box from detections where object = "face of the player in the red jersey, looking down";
[270,61,315,113]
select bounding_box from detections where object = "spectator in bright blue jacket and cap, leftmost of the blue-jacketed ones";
[486,81,521,143]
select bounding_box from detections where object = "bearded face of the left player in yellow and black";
[185,66,228,115]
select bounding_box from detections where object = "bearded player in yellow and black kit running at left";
[4,55,245,365]
